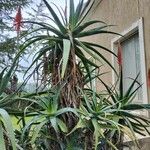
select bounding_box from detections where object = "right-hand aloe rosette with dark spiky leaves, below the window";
[99,68,150,149]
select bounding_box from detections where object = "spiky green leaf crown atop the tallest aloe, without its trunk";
[21,0,117,83]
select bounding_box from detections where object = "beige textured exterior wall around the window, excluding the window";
[87,0,150,102]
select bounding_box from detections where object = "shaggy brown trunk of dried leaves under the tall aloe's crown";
[52,51,83,130]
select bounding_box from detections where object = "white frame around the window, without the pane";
[111,18,148,104]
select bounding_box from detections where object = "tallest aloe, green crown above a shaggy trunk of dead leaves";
[20,0,117,107]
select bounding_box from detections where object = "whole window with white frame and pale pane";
[111,18,148,103]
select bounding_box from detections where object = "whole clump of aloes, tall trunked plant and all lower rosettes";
[0,0,150,150]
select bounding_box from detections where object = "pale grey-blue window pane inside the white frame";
[121,34,142,103]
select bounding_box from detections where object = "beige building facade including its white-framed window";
[86,0,150,150]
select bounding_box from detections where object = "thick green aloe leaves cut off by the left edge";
[0,65,17,150]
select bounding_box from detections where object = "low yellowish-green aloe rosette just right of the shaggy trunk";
[69,89,122,150]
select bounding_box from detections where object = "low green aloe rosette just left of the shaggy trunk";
[19,85,78,149]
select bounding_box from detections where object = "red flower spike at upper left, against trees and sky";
[14,6,22,33]
